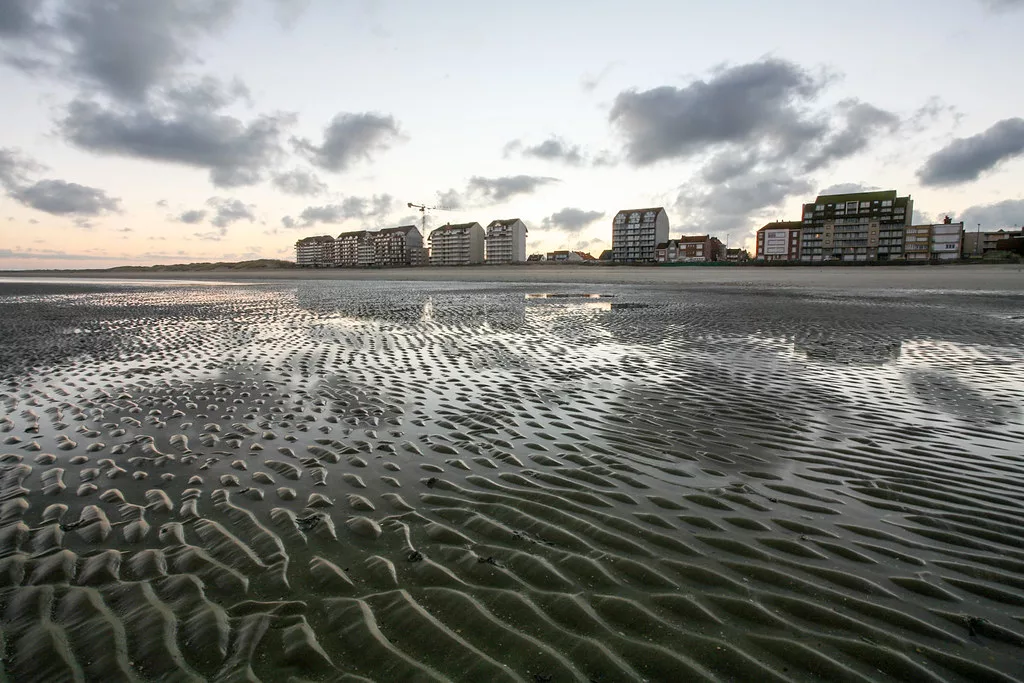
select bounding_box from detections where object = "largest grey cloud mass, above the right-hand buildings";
[609,58,907,245]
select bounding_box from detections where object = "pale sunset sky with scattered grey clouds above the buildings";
[0,0,1024,269]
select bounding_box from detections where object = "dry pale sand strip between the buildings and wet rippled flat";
[6,264,1024,291]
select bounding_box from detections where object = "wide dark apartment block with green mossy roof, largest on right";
[800,189,913,262]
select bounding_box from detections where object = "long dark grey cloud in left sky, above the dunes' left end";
[58,97,294,187]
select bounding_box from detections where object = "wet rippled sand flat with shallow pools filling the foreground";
[0,282,1024,682]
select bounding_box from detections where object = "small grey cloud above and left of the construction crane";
[292,113,402,172]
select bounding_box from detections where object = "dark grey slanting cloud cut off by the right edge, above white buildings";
[918,118,1024,186]
